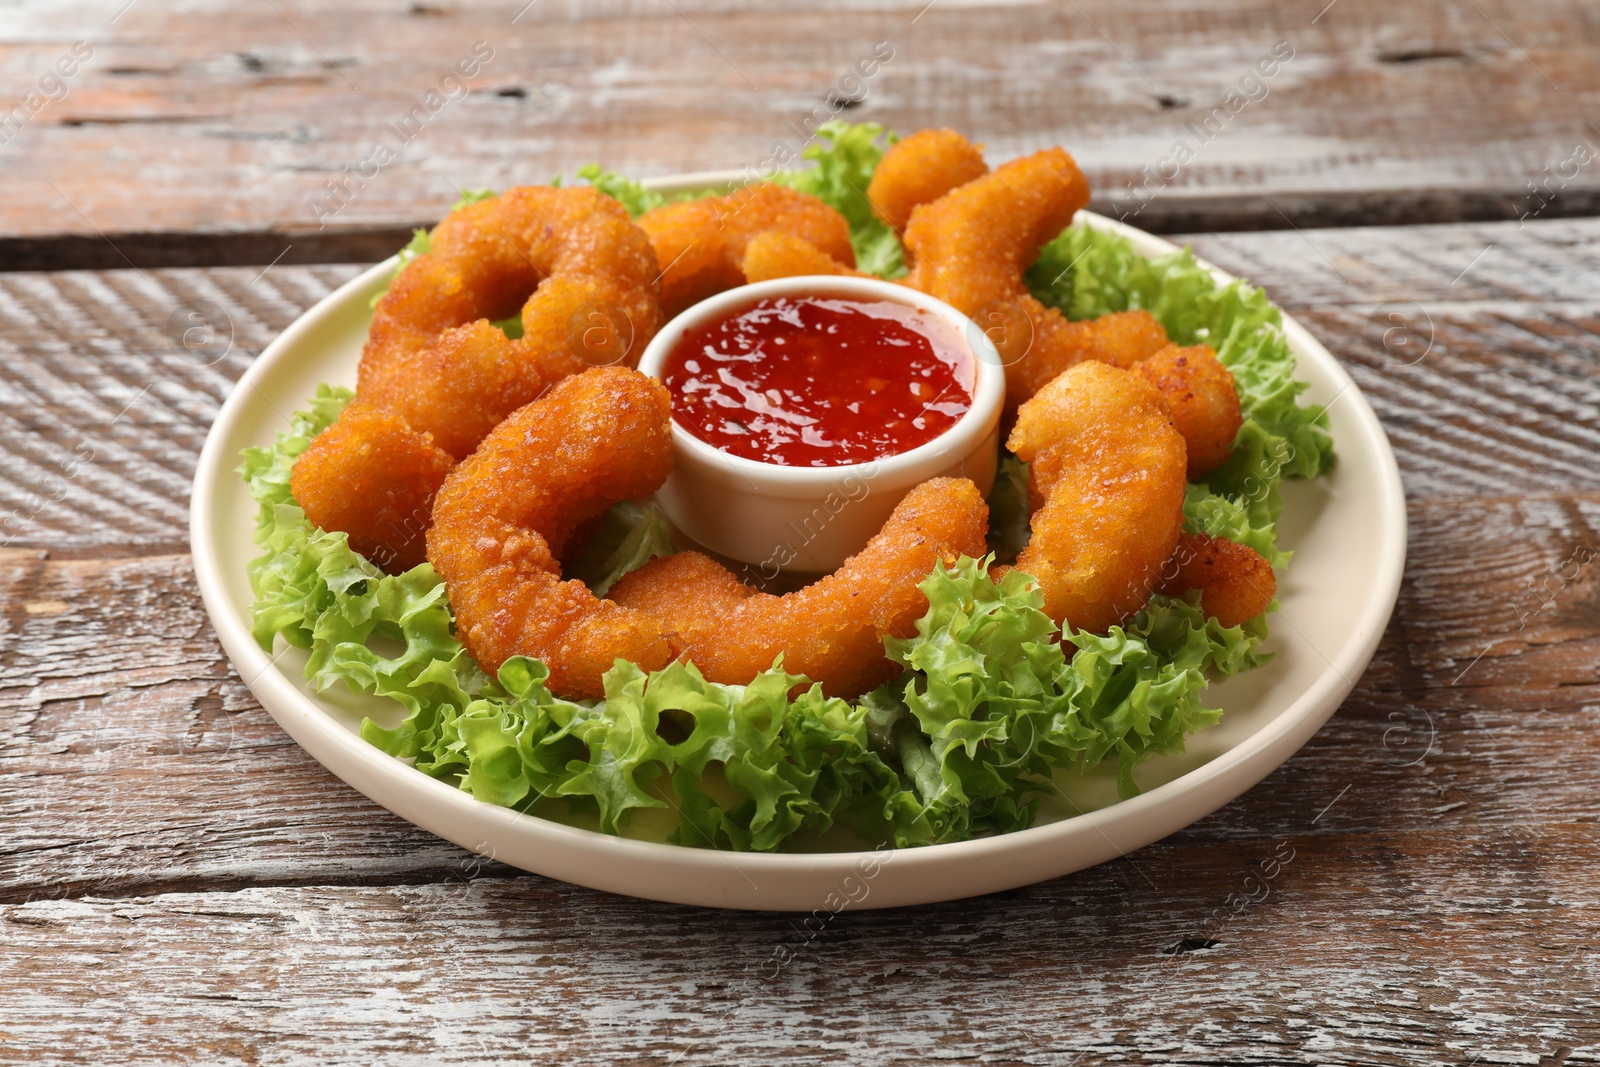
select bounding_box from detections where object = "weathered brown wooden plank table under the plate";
[0,0,1600,1064]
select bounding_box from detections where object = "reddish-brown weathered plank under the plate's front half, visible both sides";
[0,496,1600,902]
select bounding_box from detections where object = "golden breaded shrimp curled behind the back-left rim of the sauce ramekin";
[638,184,856,318]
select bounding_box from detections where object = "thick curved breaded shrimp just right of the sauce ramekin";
[1006,362,1184,633]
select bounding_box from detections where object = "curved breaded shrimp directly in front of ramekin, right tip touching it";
[611,478,989,697]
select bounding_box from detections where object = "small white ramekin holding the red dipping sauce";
[638,275,1005,581]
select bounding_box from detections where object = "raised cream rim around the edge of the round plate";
[190,171,1408,912]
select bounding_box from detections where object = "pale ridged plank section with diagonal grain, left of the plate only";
[0,267,357,555]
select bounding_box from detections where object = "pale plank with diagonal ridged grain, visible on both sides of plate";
[0,221,1600,557]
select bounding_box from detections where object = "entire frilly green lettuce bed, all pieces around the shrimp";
[240,123,1331,851]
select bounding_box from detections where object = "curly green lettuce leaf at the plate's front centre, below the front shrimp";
[428,657,915,851]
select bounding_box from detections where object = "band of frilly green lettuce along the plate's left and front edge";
[240,396,1266,849]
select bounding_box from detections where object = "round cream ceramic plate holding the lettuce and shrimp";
[190,174,1406,912]
